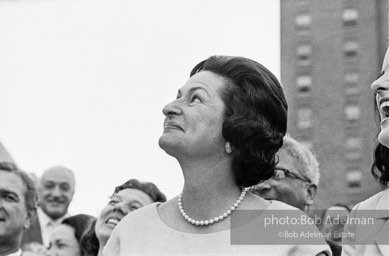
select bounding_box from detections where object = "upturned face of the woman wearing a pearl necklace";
[159,71,226,158]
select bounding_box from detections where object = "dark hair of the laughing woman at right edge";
[371,94,389,187]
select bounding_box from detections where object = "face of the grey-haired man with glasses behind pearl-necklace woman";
[253,149,316,211]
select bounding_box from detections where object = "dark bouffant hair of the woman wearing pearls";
[190,56,288,187]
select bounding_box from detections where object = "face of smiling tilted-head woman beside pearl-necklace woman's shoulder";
[95,188,154,246]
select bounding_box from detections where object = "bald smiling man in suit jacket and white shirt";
[23,166,75,246]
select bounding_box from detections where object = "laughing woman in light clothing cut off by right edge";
[342,47,389,256]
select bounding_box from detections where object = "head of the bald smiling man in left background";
[38,166,75,220]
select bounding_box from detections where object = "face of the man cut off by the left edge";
[0,170,30,245]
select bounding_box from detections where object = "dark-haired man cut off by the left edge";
[0,163,38,256]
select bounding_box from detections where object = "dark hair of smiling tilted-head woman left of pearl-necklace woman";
[113,179,166,203]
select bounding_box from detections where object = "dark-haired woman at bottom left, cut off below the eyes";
[47,214,98,256]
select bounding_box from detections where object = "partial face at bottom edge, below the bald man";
[47,224,81,256]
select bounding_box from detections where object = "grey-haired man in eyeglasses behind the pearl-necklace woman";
[251,135,320,212]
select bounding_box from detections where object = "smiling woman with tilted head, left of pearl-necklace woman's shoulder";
[82,179,166,256]
